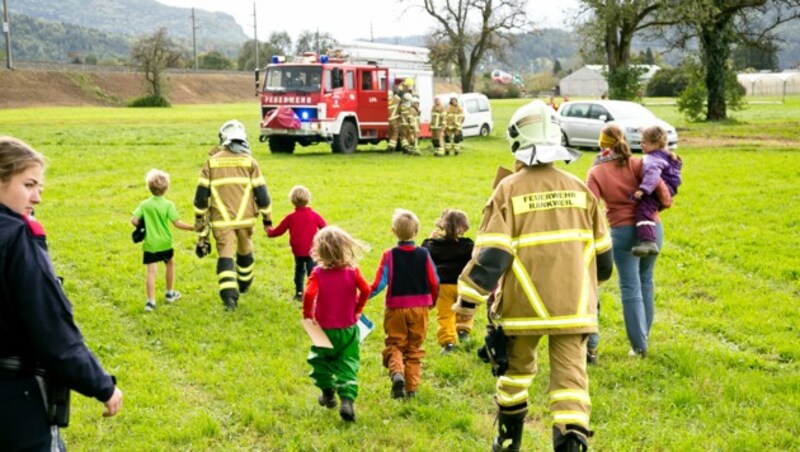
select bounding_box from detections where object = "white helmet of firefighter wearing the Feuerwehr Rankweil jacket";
[506,99,581,166]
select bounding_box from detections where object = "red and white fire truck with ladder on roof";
[255,42,433,154]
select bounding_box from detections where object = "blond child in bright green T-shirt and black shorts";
[131,169,194,311]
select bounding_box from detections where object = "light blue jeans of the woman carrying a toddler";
[611,223,664,352]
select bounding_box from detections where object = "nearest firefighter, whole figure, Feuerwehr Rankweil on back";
[453,101,612,451]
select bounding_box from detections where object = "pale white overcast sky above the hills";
[156,0,579,41]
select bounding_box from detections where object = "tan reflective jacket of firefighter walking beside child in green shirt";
[194,147,272,229]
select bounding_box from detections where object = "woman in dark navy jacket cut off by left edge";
[0,137,122,451]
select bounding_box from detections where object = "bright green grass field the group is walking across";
[0,98,800,451]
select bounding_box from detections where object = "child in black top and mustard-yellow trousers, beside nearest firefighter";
[422,209,474,354]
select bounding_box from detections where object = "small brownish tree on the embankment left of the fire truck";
[131,27,182,99]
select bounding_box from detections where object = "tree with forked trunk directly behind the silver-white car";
[579,0,666,99]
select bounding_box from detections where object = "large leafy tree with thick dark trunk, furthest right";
[664,0,800,121]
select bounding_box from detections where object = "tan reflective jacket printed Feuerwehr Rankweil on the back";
[458,164,611,335]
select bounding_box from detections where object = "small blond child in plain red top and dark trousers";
[267,185,326,301]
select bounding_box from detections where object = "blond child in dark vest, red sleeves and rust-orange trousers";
[370,209,439,399]
